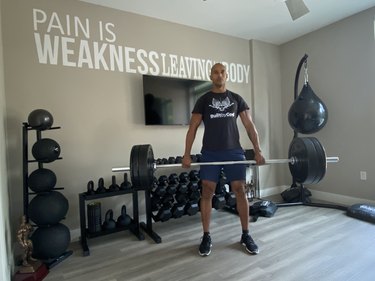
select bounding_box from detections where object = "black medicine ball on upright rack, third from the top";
[28,168,57,192]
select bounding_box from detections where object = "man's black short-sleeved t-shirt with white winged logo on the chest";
[192,90,249,150]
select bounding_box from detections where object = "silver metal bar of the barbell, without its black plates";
[112,156,339,172]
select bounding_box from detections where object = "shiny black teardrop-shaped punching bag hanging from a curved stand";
[288,83,328,134]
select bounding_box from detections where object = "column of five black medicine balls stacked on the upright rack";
[25,109,70,262]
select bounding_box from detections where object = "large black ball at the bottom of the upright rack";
[30,223,70,260]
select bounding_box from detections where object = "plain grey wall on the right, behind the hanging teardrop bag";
[280,8,375,203]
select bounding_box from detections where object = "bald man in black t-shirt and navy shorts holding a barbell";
[182,63,265,256]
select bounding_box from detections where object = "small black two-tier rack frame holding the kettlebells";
[79,188,145,256]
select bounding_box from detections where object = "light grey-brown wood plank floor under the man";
[44,203,375,281]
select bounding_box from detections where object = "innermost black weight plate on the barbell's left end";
[138,144,155,189]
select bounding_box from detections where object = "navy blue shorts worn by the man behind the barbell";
[199,149,247,182]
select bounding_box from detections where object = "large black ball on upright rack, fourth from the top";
[28,191,69,226]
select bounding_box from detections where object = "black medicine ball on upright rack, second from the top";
[31,138,61,163]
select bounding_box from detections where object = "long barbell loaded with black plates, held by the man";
[112,137,339,188]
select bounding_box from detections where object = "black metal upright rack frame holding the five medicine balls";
[22,122,73,268]
